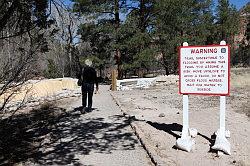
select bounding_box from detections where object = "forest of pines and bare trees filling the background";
[0,0,250,111]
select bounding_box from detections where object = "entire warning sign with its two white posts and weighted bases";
[177,41,230,154]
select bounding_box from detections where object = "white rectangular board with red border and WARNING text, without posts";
[179,45,230,95]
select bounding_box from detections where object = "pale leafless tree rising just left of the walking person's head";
[50,0,81,77]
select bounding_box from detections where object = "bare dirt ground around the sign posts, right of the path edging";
[112,68,250,166]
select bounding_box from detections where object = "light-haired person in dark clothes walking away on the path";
[82,59,99,112]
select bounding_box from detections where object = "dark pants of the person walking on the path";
[82,83,94,109]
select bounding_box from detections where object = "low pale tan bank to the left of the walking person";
[0,78,81,109]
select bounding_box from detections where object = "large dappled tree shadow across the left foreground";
[0,104,137,165]
